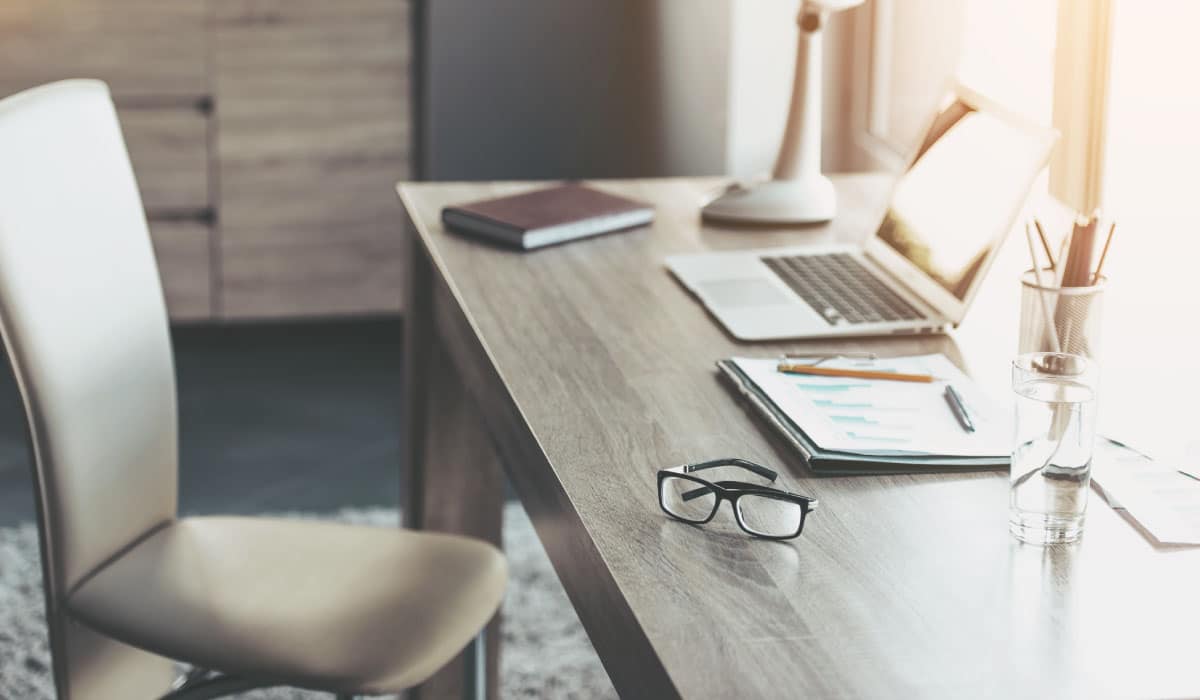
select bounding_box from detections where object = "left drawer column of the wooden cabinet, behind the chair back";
[0,0,214,321]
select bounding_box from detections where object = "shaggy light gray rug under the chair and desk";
[0,504,617,700]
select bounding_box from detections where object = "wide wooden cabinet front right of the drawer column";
[210,0,410,318]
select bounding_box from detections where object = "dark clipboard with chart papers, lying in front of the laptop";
[716,354,1012,474]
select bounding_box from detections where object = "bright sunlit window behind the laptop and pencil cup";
[846,0,1200,453]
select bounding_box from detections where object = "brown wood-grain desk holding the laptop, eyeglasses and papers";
[398,175,1200,698]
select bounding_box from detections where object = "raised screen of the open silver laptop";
[866,84,1058,325]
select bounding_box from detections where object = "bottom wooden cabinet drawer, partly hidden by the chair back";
[150,221,212,321]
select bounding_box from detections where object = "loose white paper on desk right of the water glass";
[1092,438,1200,544]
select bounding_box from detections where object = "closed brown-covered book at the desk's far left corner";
[442,185,654,250]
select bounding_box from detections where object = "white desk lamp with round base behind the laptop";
[702,0,863,223]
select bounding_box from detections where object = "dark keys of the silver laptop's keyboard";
[762,253,925,325]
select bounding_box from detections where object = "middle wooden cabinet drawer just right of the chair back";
[120,107,211,213]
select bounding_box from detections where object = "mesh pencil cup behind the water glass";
[1018,270,1106,359]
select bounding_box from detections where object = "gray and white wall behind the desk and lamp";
[418,0,850,180]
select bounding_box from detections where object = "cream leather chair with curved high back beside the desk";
[0,80,506,700]
